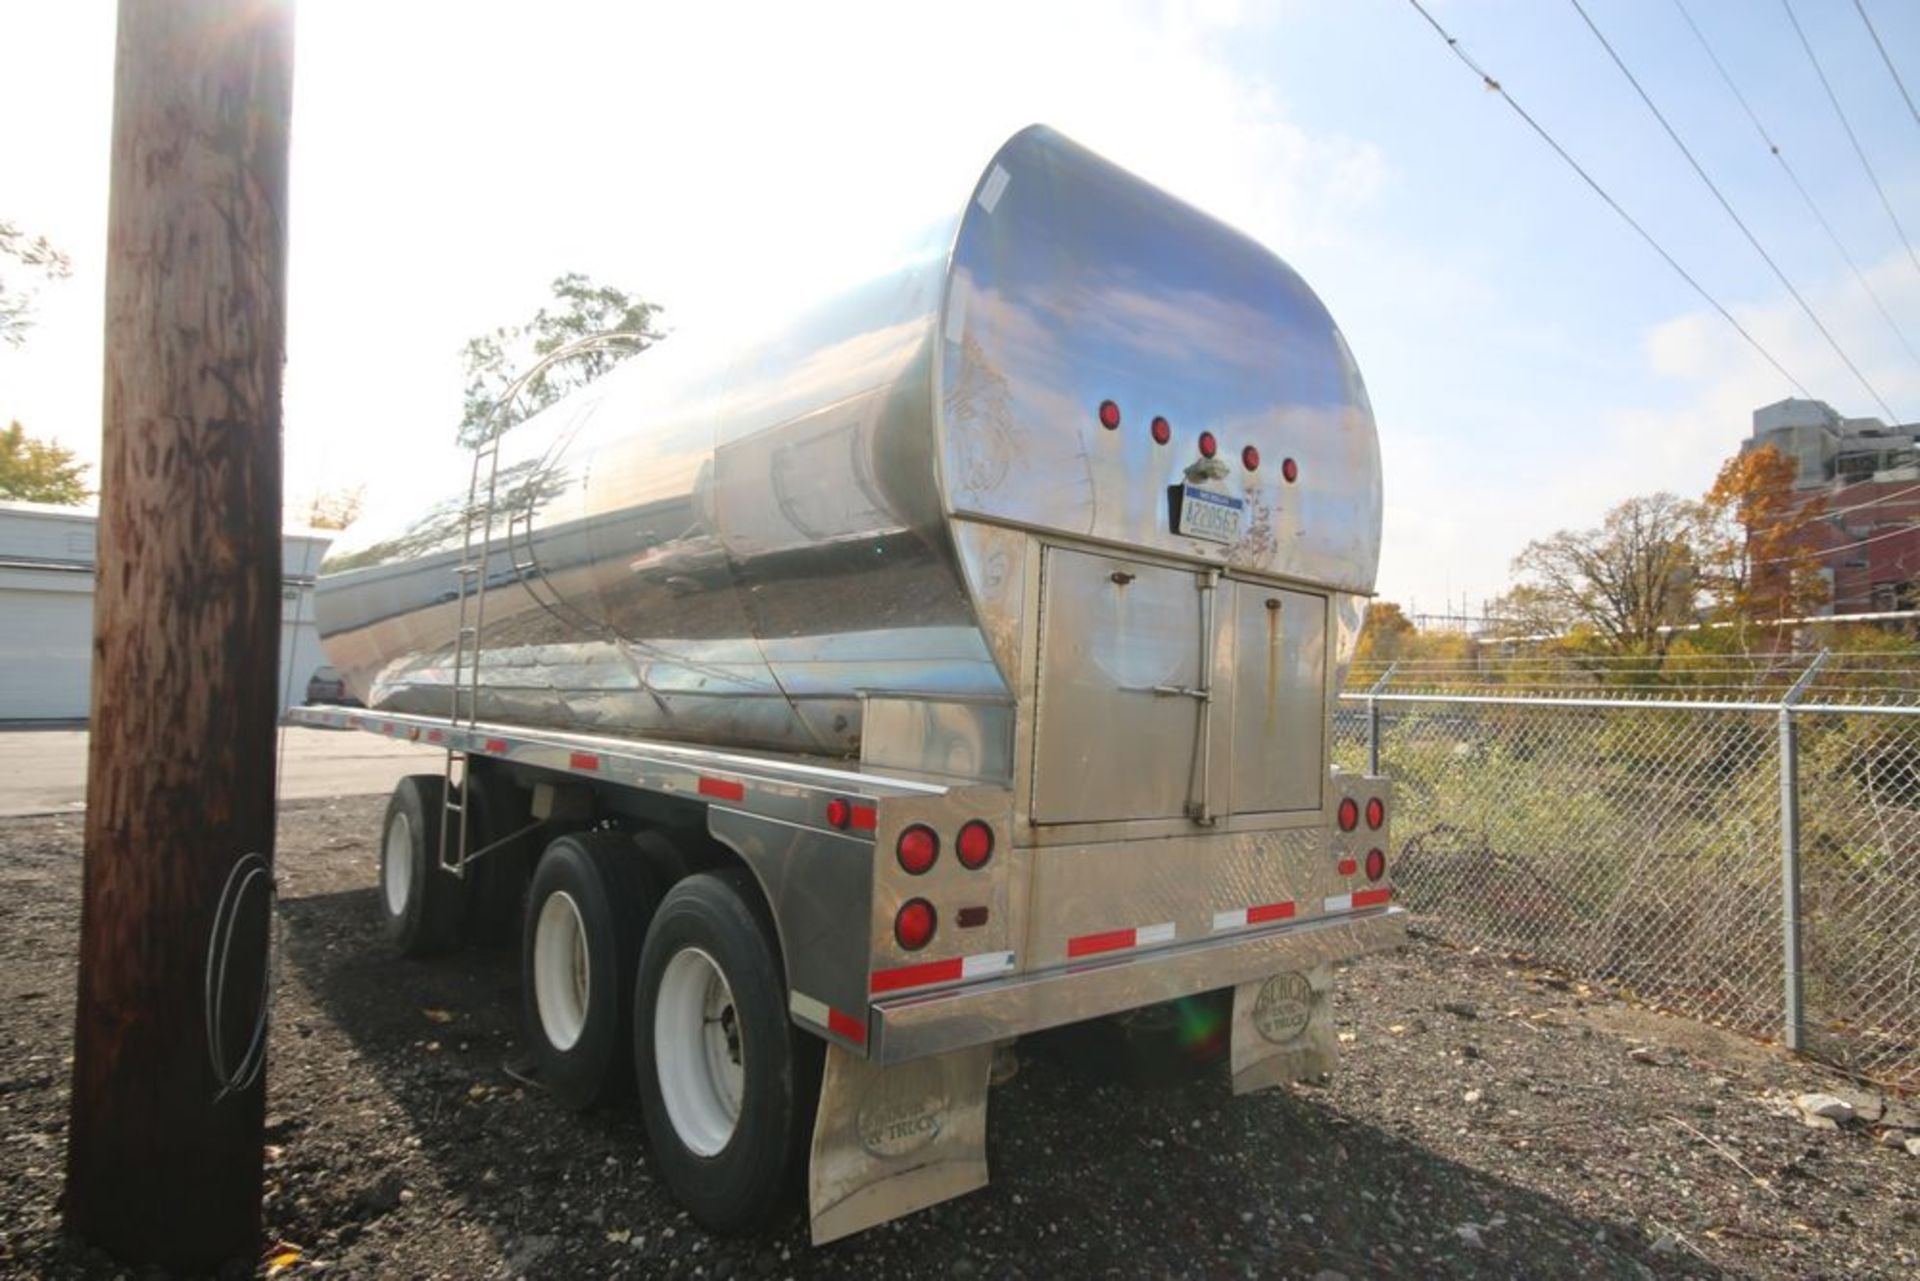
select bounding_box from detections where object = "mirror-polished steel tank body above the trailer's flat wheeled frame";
[317,127,1380,775]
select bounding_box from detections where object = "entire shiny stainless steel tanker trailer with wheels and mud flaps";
[305,129,1404,1241]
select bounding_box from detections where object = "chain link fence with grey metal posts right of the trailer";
[1334,655,1920,1089]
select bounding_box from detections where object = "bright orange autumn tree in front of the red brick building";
[1699,446,1832,622]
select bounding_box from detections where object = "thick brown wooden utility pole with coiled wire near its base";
[65,0,294,1269]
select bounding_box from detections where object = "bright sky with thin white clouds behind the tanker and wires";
[0,0,1920,613]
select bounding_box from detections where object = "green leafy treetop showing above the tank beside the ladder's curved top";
[459,273,664,446]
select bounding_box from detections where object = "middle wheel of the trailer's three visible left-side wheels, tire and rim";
[520,832,657,1110]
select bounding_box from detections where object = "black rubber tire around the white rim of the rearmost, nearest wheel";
[634,868,824,1233]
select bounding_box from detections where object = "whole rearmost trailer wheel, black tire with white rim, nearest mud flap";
[634,868,822,1233]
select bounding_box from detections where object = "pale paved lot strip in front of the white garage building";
[0,726,442,818]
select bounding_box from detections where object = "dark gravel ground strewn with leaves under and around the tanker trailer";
[0,797,1920,1281]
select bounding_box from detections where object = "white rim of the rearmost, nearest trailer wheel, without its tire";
[653,947,747,1156]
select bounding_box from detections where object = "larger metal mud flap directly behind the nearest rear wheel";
[806,1045,993,1245]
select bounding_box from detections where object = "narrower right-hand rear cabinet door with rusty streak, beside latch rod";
[1215,582,1327,814]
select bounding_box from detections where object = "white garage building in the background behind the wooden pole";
[0,503,330,724]
